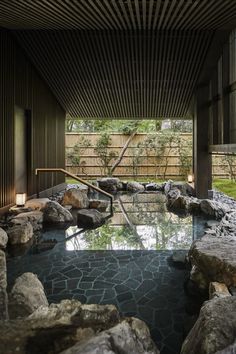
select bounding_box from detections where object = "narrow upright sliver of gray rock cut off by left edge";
[0,250,8,320]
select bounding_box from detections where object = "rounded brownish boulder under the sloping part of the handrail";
[62,188,89,209]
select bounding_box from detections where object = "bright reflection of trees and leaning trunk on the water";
[81,194,192,250]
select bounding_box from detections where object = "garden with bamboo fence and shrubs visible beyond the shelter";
[66,119,236,198]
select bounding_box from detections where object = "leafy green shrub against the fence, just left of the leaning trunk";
[94,132,117,176]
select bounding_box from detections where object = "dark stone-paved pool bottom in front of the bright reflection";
[8,243,187,354]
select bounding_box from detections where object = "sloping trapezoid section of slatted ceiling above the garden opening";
[12,30,211,118]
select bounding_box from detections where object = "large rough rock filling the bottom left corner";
[0,300,120,354]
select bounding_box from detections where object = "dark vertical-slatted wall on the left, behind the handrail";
[0,30,65,208]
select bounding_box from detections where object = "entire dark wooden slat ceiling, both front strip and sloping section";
[0,0,236,118]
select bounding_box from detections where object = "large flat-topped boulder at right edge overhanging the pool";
[189,234,236,287]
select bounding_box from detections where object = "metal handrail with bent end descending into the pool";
[35,168,113,213]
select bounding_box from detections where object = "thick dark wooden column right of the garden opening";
[194,85,212,198]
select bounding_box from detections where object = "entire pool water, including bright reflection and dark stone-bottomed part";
[7,194,212,354]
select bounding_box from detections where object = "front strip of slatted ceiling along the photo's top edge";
[0,0,236,30]
